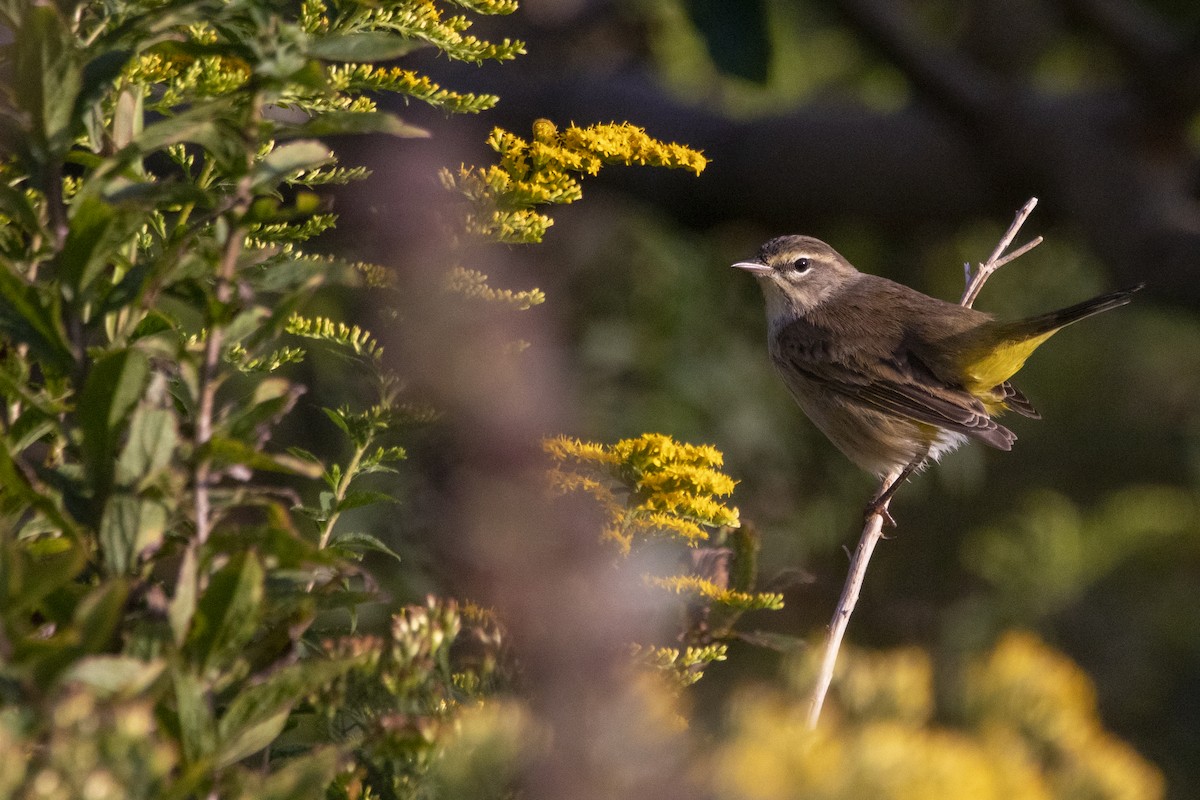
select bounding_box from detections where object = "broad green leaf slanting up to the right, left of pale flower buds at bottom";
[217,658,354,768]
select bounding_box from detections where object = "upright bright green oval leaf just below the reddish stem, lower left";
[185,553,265,669]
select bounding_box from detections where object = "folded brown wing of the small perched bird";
[775,319,1016,450]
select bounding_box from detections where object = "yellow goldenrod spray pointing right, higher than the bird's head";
[442,120,708,243]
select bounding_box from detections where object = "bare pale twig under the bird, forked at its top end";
[809,197,1042,729]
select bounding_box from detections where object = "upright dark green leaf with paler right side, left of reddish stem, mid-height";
[76,349,150,501]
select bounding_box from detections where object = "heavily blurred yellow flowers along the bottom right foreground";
[713,633,1164,800]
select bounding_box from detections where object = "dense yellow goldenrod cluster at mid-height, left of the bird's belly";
[544,433,738,553]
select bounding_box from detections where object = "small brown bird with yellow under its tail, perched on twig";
[733,235,1144,525]
